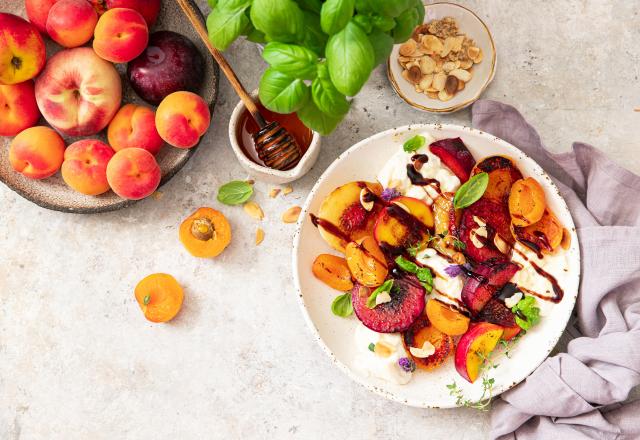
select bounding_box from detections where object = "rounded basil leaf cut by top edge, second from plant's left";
[250,0,304,43]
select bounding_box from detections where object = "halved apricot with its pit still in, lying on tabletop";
[180,208,231,258]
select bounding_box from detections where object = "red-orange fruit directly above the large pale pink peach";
[47,0,98,47]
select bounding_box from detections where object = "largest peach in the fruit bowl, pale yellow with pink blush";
[36,47,122,136]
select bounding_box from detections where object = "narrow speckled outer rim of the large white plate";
[292,124,582,408]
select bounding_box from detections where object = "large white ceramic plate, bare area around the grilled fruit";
[293,125,580,408]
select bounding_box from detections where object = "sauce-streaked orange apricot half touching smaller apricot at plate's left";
[345,236,388,287]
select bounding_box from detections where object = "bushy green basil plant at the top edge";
[207,0,424,135]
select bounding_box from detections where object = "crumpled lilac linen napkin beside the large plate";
[472,100,640,440]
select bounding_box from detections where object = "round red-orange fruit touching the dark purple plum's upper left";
[93,8,149,63]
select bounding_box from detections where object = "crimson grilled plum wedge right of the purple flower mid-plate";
[461,260,520,315]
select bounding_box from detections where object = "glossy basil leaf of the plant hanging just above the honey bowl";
[258,67,309,114]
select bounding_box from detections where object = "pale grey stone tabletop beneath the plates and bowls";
[0,0,640,439]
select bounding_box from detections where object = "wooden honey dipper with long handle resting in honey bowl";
[176,0,302,171]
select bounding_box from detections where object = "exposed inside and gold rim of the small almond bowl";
[387,2,497,113]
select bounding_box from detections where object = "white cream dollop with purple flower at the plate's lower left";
[354,323,413,385]
